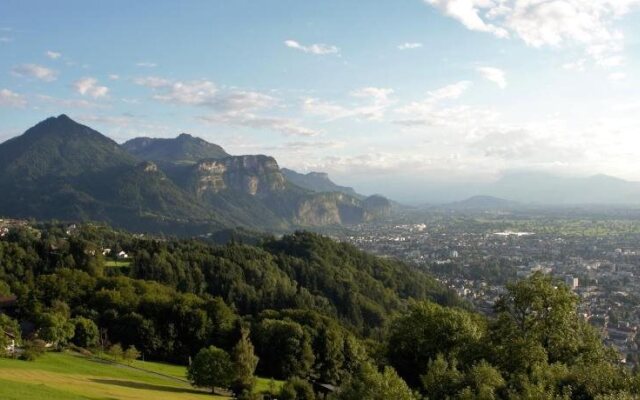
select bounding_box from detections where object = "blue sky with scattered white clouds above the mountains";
[0,0,640,198]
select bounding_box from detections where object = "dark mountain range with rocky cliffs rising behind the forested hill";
[0,115,391,233]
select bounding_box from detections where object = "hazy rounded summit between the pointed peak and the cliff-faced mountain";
[122,133,229,163]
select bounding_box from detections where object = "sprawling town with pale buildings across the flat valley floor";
[331,210,640,366]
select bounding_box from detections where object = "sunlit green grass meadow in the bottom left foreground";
[0,352,230,400]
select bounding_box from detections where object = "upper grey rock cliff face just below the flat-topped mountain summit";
[194,155,286,197]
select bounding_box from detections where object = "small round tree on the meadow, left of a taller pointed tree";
[187,346,233,392]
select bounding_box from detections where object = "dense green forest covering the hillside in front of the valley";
[0,224,640,400]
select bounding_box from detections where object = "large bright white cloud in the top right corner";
[424,0,640,67]
